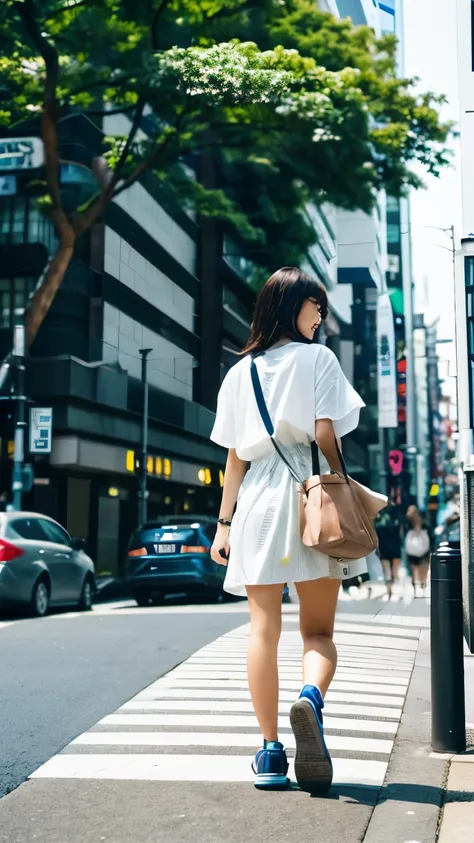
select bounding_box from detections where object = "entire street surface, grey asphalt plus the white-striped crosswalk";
[0,595,434,843]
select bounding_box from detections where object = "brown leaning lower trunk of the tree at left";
[25,225,77,348]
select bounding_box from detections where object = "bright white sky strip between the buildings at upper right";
[404,0,461,375]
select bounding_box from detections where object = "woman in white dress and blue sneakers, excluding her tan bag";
[211,267,367,793]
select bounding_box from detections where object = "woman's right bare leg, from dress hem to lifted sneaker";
[296,578,341,697]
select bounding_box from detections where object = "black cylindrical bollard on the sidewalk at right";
[431,543,466,752]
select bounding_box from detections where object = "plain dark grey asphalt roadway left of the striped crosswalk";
[0,603,247,796]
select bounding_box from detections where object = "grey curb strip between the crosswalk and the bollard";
[364,630,449,843]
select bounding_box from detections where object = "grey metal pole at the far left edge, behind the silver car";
[11,324,27,511]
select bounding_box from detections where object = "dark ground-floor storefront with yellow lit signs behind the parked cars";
[0,436,223,577]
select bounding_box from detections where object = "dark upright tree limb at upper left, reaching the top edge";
[19,0,63,213]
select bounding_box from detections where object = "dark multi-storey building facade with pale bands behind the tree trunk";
[0,118,254,575]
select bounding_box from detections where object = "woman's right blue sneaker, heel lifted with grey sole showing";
[290,685,333,794]
